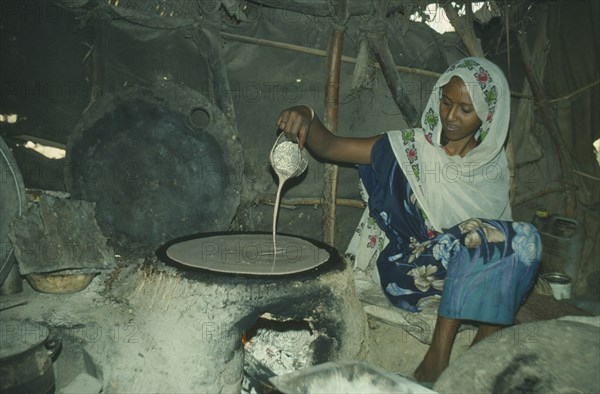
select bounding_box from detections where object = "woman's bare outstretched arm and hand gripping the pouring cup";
[277,105,380,164]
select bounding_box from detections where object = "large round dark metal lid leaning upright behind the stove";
[65,81,244,246]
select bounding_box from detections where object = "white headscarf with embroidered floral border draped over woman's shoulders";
[388,58,512,231]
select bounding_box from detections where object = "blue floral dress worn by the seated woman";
[359,135,541,325]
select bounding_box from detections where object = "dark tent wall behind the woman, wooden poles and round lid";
[0,0,600,298]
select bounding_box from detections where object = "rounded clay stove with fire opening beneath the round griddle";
[105,233,368,393]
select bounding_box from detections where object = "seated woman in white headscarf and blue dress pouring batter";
[277,58,541,382]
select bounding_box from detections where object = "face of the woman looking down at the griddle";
[440,76,481,141]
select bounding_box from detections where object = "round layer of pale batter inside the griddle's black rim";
[166,233,330,276]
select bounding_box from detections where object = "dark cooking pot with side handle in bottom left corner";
[0,320,62,394]
